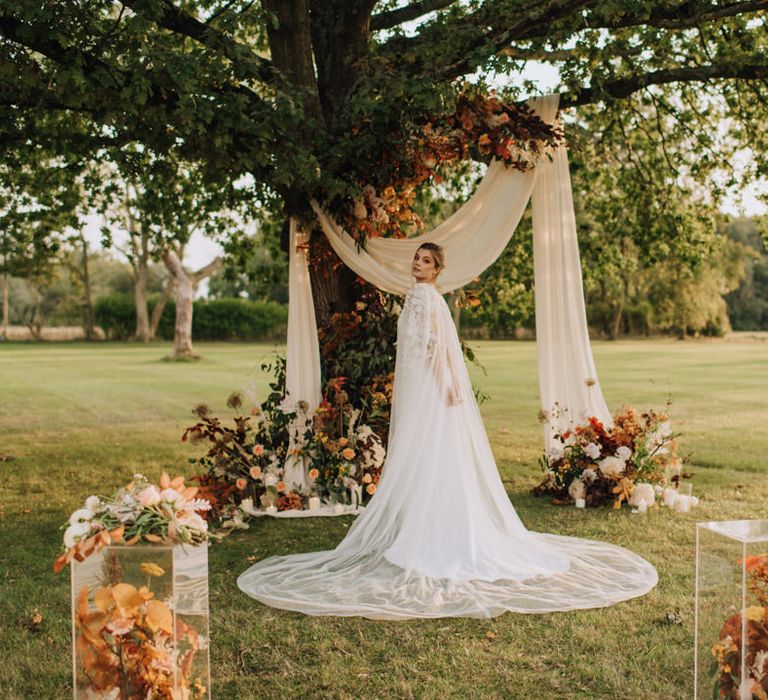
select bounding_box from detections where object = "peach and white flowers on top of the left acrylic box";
[54,472,211,572]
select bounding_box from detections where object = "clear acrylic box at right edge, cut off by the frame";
[694,520,768,700]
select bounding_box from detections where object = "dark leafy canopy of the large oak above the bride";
[0,0,768,332]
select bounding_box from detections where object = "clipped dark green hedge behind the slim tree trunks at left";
[94,293,288,340]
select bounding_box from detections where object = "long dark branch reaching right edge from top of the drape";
[560,63,768,109]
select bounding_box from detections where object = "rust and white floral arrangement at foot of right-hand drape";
[533,406,690,508]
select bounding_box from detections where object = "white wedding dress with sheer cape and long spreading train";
[238,283,658,619]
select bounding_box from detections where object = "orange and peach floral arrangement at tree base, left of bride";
[182,360,385,516]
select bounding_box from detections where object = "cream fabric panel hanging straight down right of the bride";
[532,135,611,448]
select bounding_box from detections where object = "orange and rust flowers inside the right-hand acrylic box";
[712,554,768,700]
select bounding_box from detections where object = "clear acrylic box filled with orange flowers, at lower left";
[71,544,211,700]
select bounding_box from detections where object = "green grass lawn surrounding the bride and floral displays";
[0,340,768,700]
